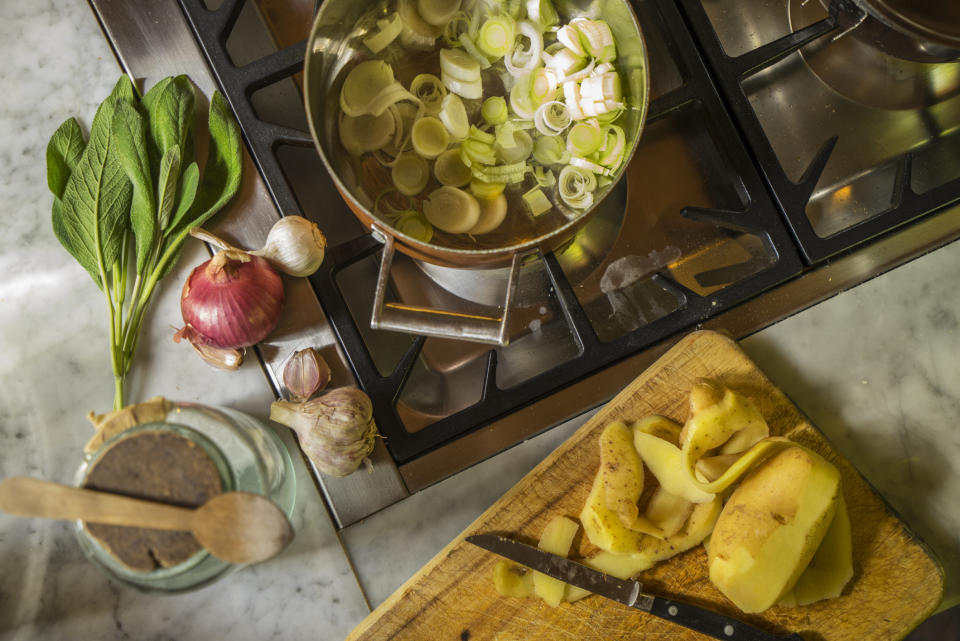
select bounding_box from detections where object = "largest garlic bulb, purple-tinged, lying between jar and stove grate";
[270,387,377,477]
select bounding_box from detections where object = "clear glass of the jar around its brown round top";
[74,402,296,593]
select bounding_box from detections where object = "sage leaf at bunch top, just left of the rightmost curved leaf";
[143,76,196,178]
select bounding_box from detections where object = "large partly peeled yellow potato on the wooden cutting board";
[708,447,840,612]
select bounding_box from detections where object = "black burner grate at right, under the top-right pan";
[680,0,960,264]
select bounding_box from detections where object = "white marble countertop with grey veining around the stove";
[0,0,960,641]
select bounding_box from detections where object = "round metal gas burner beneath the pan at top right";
[788,0,960,110]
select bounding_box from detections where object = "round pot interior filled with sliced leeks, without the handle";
[304,0,649,340]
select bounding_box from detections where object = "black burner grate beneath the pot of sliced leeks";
[180,0,802,463]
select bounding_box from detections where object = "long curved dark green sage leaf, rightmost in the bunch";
[161,91,243,274]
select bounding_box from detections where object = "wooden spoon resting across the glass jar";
[0,476,293,563]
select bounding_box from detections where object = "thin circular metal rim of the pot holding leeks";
[303,0,650,264]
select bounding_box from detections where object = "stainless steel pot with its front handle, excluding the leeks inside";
[304,0,649,345]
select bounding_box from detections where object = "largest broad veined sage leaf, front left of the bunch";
[53,98,133,289]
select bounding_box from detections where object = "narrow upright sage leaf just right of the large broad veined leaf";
[111,100,156,274]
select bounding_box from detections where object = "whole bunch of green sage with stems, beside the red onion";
[47,76,243,409]
